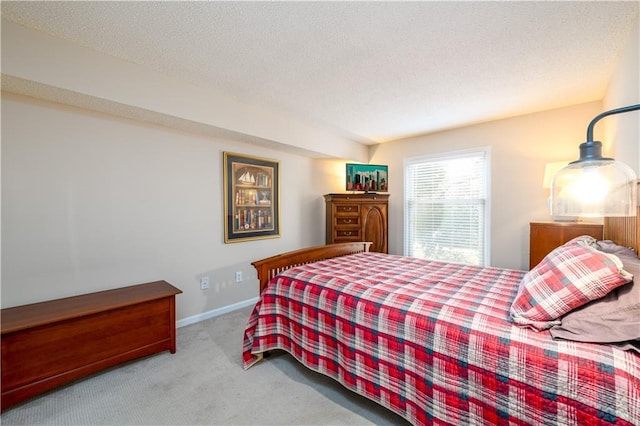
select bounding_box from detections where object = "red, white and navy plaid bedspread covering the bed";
[243,253,640,425]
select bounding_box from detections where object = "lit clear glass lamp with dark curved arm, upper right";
[551,104,640,217]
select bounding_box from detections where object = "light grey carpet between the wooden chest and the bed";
[0,308,407,425]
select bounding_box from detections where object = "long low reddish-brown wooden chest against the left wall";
[1,281,182,410]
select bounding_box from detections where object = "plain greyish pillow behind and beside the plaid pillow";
[549,241,640,352]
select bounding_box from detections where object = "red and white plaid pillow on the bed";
[511,240,632,331]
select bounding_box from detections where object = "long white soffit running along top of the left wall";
[1,20,366,161]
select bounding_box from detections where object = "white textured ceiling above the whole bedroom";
[1,1,640,143]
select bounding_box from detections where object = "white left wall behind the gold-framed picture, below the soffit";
[2,93,324,319]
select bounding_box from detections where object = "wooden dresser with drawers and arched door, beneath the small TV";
[324,193,389,253]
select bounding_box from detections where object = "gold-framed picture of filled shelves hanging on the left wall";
[223,152,280,243]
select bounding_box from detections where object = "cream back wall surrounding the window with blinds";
[370,102,601,269]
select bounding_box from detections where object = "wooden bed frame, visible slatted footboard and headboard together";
[252,207,640,294]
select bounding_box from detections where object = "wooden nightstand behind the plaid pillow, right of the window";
[529,222,603,269]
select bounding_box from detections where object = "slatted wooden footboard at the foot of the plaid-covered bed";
[251,242,371,293]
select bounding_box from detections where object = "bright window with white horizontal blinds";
[404,148,489,266]
